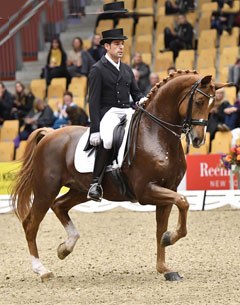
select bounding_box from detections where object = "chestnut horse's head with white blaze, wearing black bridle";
[179,75,228,148]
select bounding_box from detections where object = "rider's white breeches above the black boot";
[100,107,134,149]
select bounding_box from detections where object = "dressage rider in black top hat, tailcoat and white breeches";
[87,28,146,201]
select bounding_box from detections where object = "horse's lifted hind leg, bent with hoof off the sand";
[51,189,87,259]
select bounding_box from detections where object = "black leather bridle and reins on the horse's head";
[136,79,215,139]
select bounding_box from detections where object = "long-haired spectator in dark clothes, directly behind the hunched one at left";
[11,81,34,126]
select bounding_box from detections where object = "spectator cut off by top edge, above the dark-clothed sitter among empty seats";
[165,0,195,15]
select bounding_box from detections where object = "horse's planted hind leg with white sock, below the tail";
[23,200,53,281]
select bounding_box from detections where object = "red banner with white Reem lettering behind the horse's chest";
[186,154,237,190]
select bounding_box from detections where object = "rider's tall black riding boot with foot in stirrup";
[87,143,111,201]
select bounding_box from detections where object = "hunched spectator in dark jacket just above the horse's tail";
[14,99,54,148]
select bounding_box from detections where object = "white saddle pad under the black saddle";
[74,108,134,173]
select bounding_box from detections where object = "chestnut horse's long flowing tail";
[11,128,53,222]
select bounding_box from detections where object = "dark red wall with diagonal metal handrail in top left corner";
[0,0,66,80]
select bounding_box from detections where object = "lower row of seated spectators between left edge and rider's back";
[0,81,89,148]
